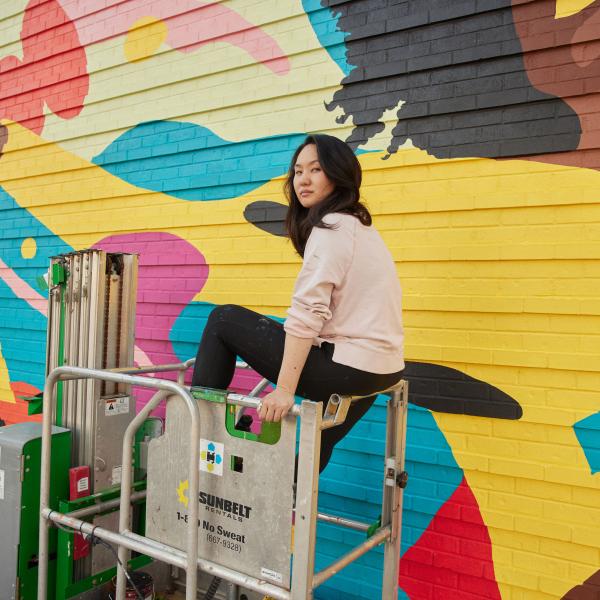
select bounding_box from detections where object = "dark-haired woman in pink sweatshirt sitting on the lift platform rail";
[192,134,404,471]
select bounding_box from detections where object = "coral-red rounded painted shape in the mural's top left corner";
[0,0,89,134]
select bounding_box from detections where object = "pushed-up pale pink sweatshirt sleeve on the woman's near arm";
[283,215,356,338]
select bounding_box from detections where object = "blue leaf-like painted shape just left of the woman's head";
[93,121,306,201]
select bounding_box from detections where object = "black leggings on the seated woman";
[192,304,402,471]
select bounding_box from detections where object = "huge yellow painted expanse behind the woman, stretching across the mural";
[0,123,600,598]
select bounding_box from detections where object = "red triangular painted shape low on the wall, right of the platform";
[399,478,501,600]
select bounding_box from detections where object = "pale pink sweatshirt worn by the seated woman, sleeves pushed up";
[284,213,404,373]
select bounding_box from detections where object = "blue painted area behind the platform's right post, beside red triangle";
[315,404,463,600]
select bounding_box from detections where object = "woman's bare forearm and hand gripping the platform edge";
[258,333,312,421]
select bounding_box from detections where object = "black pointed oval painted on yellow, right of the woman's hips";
[404,361,523,420]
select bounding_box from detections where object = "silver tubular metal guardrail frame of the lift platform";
[38,359,408,600]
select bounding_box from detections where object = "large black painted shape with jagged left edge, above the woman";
[321,0,581,158]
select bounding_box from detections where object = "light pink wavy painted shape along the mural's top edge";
[61,0,290,75]
